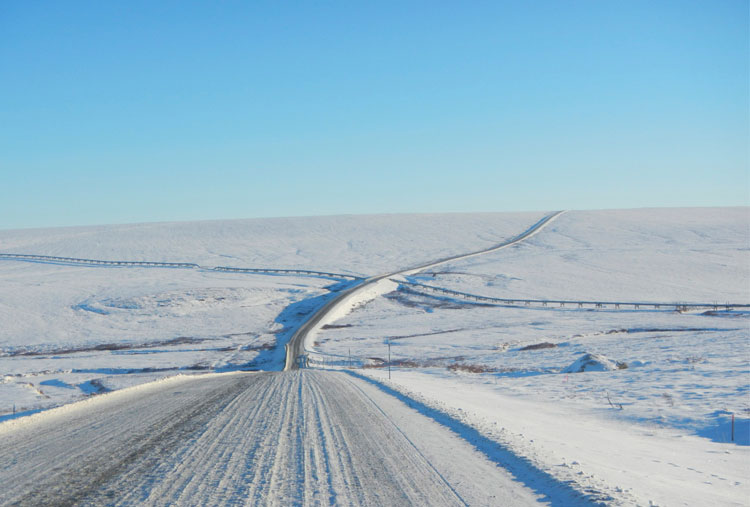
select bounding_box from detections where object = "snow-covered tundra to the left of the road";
[0,213,543,420]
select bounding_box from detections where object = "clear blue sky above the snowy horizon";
[0,0,750,229]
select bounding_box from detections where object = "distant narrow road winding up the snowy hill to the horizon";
[284,211,564,371]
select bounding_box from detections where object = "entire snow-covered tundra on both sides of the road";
[0,208,750,505]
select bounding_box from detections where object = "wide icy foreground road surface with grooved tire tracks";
[0,370,539,505]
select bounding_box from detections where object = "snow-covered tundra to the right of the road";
[311,209,750,505]
